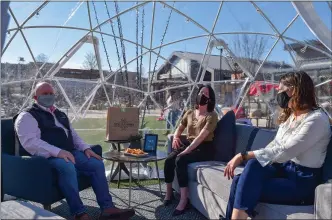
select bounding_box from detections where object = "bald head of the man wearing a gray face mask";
[33,82,55,108]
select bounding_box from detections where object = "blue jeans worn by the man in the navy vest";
[48,150,114,215]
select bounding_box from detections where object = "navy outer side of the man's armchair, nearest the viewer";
[1,153,54,202]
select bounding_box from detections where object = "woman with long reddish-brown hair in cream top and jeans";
[224,72,331,219]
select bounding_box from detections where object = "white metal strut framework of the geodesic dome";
[1,1,332,131]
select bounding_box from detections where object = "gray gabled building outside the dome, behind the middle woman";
[153,51,292,107]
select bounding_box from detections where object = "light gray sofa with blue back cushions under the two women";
[169,124,332,219]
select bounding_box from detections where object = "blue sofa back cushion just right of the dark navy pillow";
[235,124,258,154]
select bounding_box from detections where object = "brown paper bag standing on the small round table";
[106,107,139,141]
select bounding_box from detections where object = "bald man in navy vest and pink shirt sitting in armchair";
[14,82,135,219]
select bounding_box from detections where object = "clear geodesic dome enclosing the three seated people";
[1,1,332,138]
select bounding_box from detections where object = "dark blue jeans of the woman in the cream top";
[226,159,321,219]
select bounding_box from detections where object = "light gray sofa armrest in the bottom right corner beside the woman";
[315,182,332,219]
